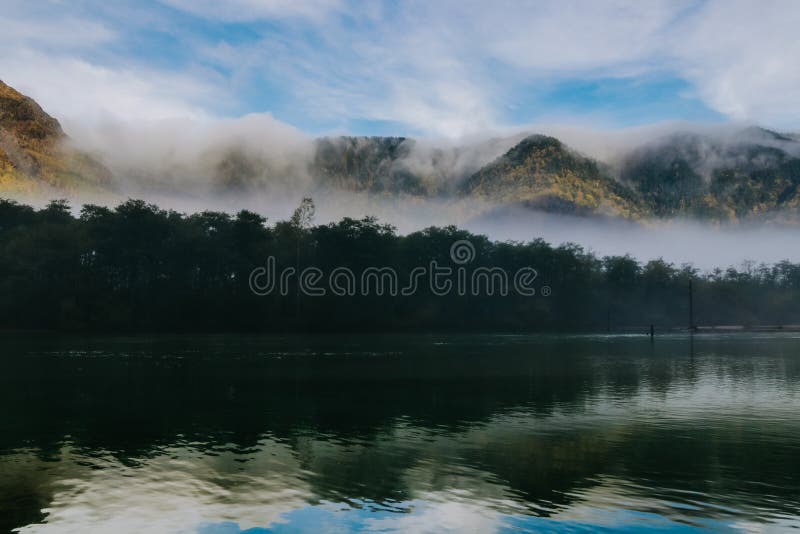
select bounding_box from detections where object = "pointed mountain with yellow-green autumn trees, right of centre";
[460,135,643,218]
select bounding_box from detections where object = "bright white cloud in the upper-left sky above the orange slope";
[0,0,224,122]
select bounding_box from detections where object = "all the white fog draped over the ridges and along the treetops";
[51,115,800,269]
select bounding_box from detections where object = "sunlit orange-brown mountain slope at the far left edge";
[0,81,111,194]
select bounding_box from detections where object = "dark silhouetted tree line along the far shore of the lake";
[0,199,800,332]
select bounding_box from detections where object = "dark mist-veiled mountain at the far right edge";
[619,128,800,220]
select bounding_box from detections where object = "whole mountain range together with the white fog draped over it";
[0,79,800,226]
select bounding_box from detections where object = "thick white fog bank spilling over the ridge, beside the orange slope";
[66,114,313,197]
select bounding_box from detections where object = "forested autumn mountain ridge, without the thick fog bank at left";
[0,81,800,221]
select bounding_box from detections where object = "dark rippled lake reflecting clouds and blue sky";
[0,333,800,534]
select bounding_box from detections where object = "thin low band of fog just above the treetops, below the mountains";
[45,188,800,271]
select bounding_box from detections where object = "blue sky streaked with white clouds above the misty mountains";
[0,0,800,138]
